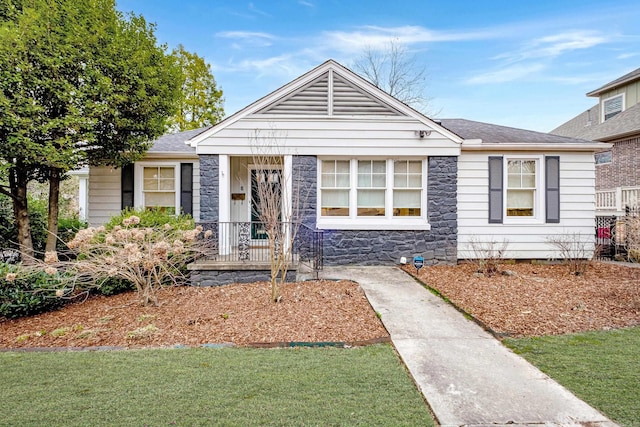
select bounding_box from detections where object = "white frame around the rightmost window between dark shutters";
[502,154,545,225]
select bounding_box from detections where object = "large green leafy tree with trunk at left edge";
[0,0,180,258]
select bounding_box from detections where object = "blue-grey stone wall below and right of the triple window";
[322,156,458,265]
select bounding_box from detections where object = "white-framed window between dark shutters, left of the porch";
[134,162,180,214]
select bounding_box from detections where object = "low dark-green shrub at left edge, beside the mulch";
[0,264,68,319]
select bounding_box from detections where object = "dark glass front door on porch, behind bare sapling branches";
[250,167,282,240]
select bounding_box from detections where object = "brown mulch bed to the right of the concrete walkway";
[406,262,640,337]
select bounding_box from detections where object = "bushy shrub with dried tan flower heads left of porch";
[64,215,213,305]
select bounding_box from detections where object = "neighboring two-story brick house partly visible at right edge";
[551,68,640,212]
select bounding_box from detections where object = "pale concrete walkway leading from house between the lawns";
[321,267,616,427]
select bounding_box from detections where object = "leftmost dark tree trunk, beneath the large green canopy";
[9,162,35,264]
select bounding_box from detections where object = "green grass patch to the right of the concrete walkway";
[504,327,640,427]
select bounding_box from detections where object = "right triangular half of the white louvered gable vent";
[333,75,399,116]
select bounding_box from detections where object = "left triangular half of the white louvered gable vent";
[260,72,329,115]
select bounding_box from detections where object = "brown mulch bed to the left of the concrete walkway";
[0,281,388,348]
